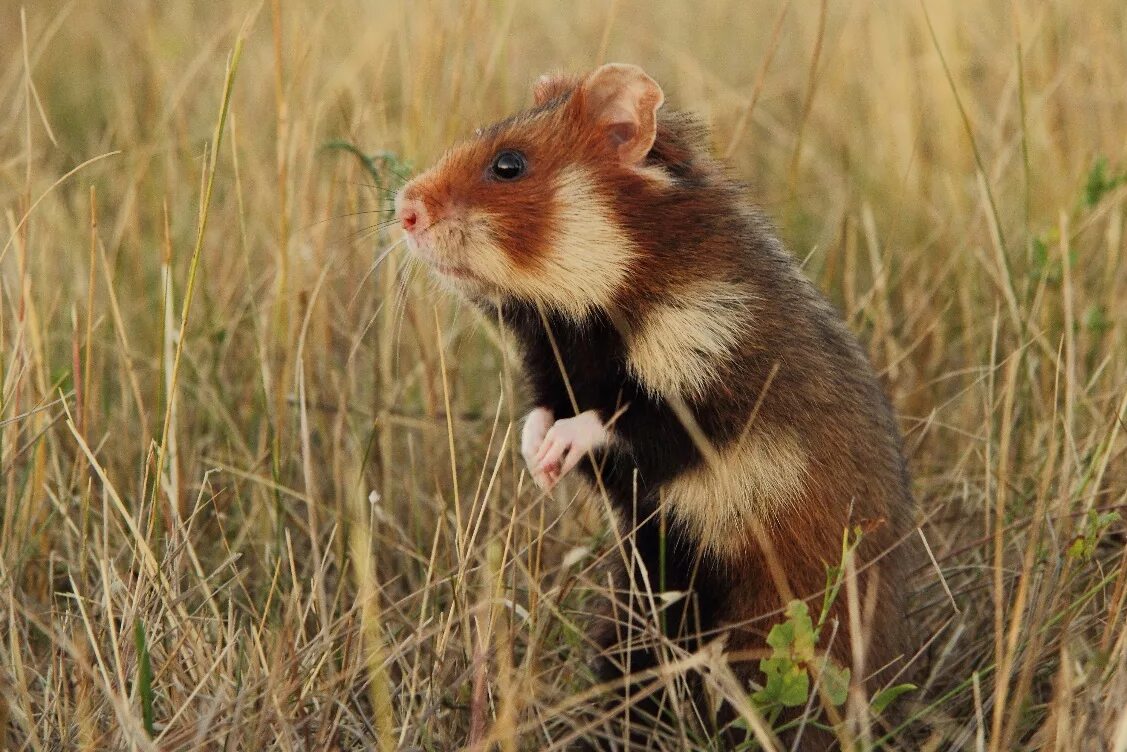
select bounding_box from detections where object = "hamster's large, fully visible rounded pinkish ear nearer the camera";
[582,63,665,165]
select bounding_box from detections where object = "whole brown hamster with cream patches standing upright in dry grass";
[397,64,919,749]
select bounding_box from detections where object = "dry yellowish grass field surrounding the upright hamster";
[0,0,1127,752]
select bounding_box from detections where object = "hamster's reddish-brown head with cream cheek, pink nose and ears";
[396,64,668,319]
